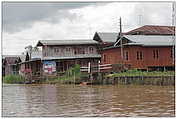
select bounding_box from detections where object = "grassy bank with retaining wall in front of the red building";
[102,70,175,86]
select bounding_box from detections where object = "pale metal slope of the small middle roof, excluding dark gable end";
[97,32,118,43]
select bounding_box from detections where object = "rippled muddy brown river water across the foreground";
[2,84,175,117]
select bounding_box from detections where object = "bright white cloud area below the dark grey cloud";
[3,3,171,54]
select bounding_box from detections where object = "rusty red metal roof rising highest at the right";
[125,25,175,35]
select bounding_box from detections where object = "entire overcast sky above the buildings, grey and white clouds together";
[2,2,172,55]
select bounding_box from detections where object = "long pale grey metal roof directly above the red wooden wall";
[124,35,175,46]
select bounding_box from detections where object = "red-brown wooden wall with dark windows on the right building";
[101,46,174,69]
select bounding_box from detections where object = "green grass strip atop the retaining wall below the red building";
[106,69,175,78]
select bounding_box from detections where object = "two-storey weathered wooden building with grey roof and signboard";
[37,39,101,74]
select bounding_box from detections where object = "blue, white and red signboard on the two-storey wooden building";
[43,61,56,74]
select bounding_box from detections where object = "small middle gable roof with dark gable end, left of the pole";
[93,32,118,43]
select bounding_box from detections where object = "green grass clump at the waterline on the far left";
[3,75,25,84]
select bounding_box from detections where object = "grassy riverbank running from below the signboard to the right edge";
[44,70,175,86]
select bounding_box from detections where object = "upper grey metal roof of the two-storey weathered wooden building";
[37,39,98,46]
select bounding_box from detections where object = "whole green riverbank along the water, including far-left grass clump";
[3,69,175,86]
